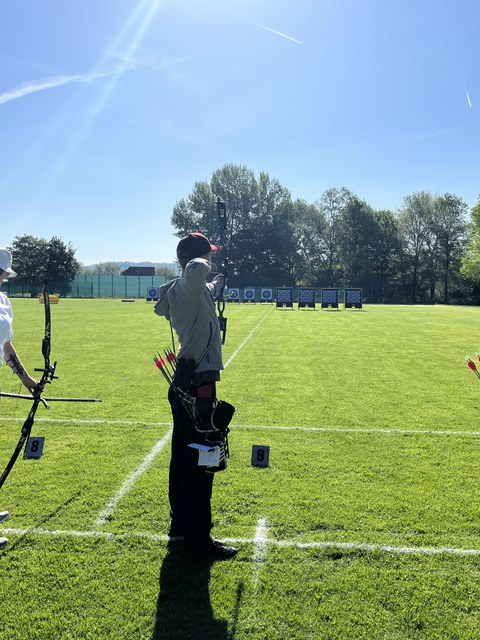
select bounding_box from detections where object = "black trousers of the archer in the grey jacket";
[168,389,214,543]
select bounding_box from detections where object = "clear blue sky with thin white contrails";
[0,0,480,264]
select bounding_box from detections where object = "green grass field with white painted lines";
[0,299,480,640]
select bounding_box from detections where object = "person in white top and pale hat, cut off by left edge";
[0,247,38,549]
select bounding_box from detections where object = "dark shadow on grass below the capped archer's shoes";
[151,542,232,640]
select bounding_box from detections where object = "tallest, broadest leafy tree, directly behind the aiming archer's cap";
[171,164,297,286]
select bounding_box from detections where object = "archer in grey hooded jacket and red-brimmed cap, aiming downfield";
[155,233,237,560]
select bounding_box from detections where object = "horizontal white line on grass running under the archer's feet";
[0,527,480,562]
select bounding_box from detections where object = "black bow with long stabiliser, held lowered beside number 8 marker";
[0,281,101,488]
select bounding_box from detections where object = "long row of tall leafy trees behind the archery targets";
[171,164,480,304]
